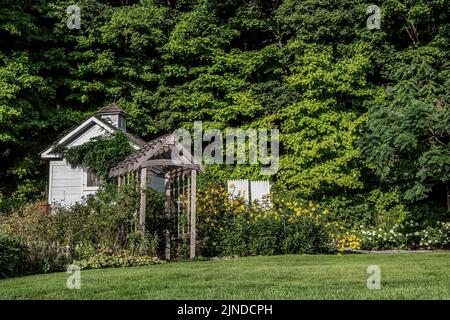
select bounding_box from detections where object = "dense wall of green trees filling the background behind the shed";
[0,0,450,220]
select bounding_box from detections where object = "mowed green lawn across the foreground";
[0,252,450,299]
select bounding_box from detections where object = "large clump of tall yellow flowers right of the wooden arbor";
[197,186,360,256]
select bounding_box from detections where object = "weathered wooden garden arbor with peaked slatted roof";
[109,134,203,260]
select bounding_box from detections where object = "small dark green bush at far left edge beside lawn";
[0,233,25,278]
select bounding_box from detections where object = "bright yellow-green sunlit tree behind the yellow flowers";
[279,45,371,197]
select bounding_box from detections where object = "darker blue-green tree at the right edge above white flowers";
[365,61,450,210]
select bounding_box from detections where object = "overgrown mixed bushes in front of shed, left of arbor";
[0,183,165,274]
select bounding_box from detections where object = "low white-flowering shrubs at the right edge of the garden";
[359,220,450,250]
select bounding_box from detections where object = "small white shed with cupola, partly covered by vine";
[41,103,145,205]
